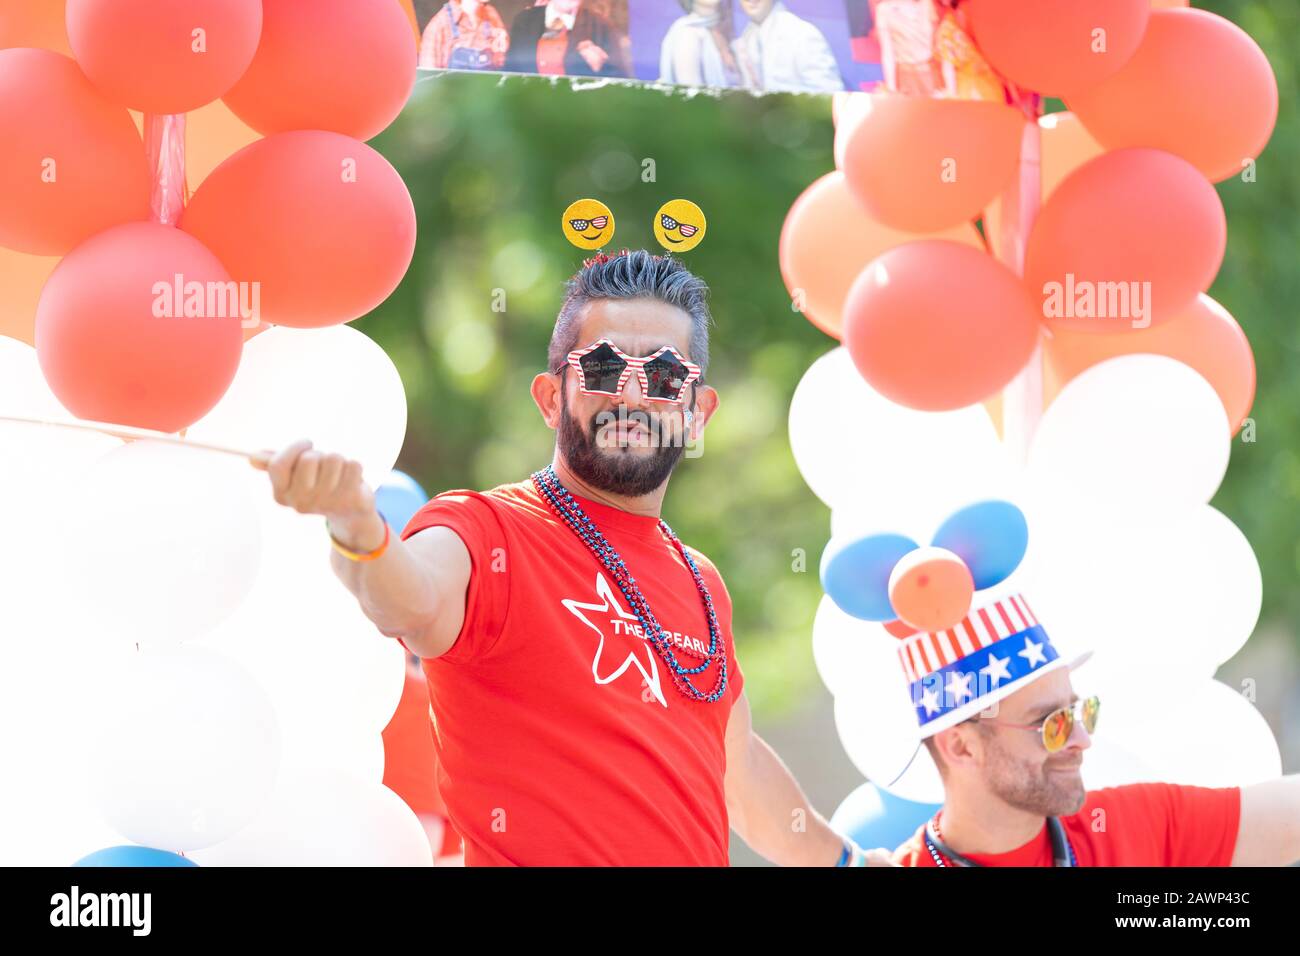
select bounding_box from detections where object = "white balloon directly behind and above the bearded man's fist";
[187,325,407,488]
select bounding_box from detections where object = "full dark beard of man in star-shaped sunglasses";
[558,406,685,497]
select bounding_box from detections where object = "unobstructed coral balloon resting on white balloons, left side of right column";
[844,239,1039,411]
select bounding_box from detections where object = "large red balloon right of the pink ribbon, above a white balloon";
[181,130,416,329]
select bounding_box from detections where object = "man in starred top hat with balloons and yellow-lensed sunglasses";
[823,502,1300,866]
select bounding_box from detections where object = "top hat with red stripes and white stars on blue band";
[885,593,1092,739]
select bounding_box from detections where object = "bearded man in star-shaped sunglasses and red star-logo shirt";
[252,250,889,866]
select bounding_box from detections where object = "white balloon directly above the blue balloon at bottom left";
[82,646,280,851]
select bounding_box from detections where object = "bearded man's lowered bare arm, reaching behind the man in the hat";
[725,693,893,866]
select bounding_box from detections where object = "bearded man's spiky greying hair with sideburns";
[546,248,712,385]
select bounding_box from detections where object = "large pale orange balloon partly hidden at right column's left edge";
[779,170,984,338]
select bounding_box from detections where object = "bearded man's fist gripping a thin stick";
[250,438,385,551]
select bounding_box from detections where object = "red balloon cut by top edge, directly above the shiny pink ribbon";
[68,0,261,113]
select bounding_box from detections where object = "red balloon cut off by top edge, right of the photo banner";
[962,0,1151,96]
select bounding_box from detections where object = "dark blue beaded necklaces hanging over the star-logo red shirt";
[532,464,727,702]
